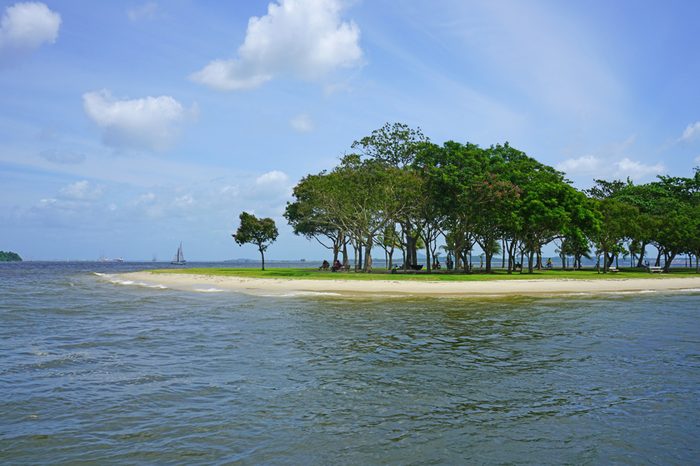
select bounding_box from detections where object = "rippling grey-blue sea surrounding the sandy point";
[0,262,700,465]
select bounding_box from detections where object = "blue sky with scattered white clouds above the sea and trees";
[0,0,700,261]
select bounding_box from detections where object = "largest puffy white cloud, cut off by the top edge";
[191,0,362,91]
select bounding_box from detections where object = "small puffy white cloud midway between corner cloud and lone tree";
[83,90,196,151]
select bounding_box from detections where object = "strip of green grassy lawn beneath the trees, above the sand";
[152,267,700,281]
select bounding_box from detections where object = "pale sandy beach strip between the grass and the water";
[110,272,700,297]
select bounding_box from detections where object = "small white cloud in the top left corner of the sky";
[0,2,61,52]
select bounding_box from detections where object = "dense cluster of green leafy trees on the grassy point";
[285,123,700,273]
